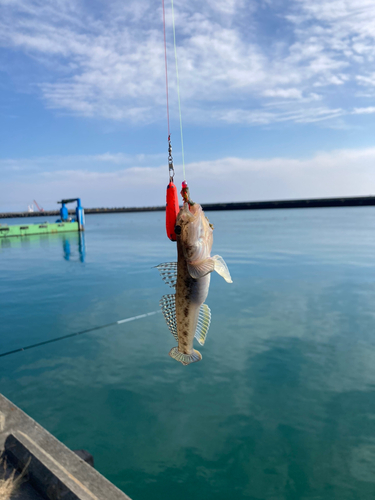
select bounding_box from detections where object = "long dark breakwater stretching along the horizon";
[0,196,375,219]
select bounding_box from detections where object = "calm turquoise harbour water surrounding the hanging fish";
[0,207,375,500]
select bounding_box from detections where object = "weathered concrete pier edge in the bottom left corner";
[0,394,130,500]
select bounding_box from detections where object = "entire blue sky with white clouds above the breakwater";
[0,0,375,211]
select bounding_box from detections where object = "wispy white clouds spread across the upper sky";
[0,0,375,124]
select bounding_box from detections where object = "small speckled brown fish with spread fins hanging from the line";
[156,199,232,366]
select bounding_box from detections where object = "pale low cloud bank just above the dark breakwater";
[0,148,375,211]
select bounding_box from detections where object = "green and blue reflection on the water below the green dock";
[0,232,86,262]
